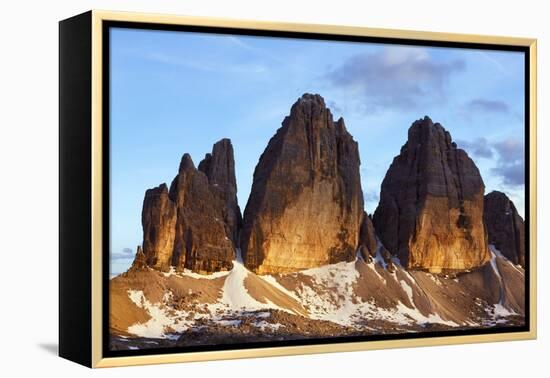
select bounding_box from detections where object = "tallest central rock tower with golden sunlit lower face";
[241,94,363,274]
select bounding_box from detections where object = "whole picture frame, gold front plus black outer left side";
[60,10,537,368]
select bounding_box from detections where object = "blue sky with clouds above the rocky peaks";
[111,28,525,273]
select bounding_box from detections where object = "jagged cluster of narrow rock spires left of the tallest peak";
[136,139,241,273]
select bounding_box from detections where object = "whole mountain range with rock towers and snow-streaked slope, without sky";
[113,94,525,350]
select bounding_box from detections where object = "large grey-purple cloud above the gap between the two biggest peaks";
[327,46,466,109]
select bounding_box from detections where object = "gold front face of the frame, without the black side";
[91,10,537,368]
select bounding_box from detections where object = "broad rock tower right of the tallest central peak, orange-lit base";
[373,117,490,273]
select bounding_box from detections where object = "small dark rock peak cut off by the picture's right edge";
[483,191,525,268]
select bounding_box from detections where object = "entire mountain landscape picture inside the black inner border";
[108,27,528,353]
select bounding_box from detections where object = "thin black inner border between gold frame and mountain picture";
[101,21,531,357]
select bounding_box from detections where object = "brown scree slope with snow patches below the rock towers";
[111,246,524,340]
